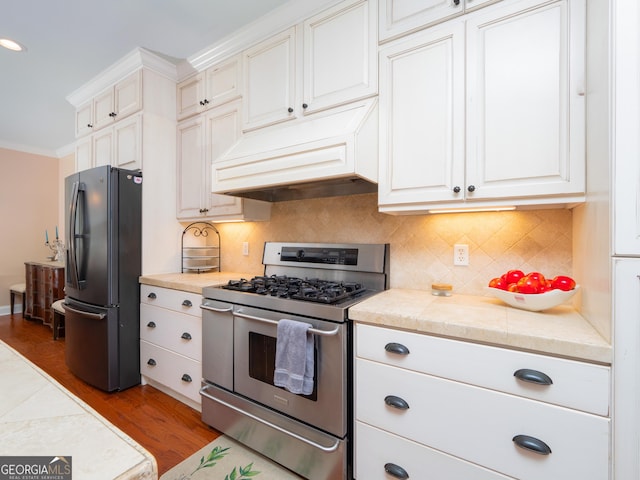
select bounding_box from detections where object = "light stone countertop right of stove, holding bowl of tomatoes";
[349,289,611,364]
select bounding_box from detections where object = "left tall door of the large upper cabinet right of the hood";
[379,21,464,208]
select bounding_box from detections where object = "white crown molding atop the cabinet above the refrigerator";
[65,47,177,108]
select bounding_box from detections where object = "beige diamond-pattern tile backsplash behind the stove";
[217,194,572,295]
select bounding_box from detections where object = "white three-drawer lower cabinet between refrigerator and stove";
[140,285,202,410]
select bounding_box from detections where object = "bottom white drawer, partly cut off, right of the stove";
[355,422,511,480]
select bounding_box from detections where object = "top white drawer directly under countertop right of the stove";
[356,324,611,416]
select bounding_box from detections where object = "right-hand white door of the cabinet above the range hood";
[302,0,378,113]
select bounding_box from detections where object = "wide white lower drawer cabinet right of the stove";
[355,324,610,480]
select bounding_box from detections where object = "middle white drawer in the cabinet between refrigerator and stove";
[140,303,202,361]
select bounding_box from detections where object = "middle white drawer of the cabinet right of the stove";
[356,358,609,480]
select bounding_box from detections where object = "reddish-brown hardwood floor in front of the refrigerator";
[0,314,220,475]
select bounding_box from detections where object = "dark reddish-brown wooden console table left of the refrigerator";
[24,262,64,328]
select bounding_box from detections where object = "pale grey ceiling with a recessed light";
[0,0,296,156]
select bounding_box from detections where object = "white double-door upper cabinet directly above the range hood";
[243,0,378,131]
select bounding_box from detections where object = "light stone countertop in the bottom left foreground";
[0,341,158,480]
